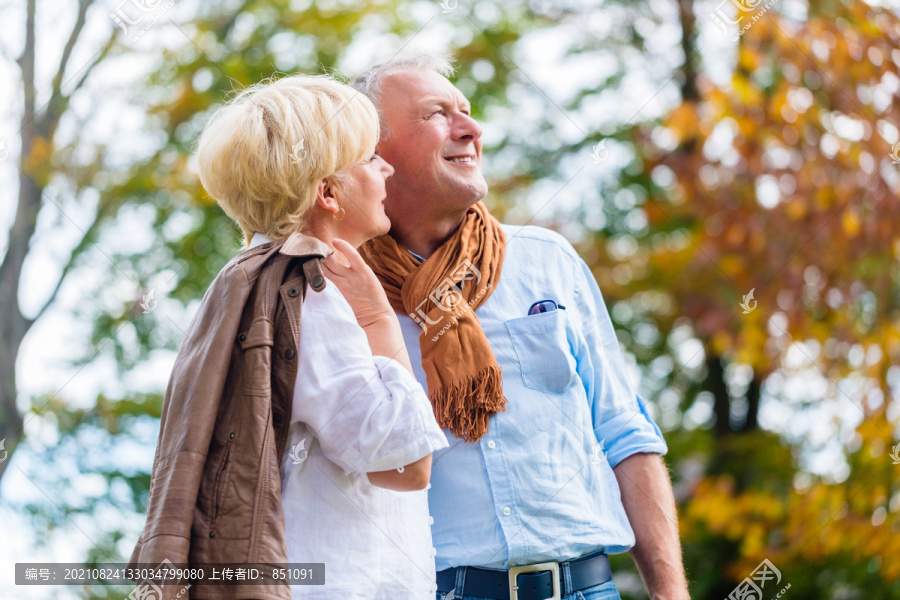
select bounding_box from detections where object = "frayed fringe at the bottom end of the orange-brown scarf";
[429,366,506,442]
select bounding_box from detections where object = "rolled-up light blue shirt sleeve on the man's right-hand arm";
[574,259,668,467]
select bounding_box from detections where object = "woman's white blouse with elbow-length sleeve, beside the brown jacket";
[251,233,449,600]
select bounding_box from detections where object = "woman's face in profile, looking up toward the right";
[338,154,394,247]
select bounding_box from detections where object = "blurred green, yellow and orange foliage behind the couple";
[7,0,900,600]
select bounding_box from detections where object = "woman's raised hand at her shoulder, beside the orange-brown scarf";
[323,238,396,329]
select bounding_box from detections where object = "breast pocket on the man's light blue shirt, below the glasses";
[506,310,576,394]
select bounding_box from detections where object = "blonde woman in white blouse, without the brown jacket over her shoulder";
[198,76,448,600]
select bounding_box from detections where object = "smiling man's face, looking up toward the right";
[378,69,487,220]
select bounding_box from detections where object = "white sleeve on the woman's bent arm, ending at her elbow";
[291,286,449,473]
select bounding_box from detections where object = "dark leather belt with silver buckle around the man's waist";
[437,552,612,600]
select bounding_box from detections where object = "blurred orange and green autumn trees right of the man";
[587,2,900,598]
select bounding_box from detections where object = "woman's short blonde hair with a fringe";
[197,75,380,247]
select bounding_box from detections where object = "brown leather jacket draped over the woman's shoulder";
[129,233,331,600]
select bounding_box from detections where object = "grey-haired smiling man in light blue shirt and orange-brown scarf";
[352,54,689,600]
